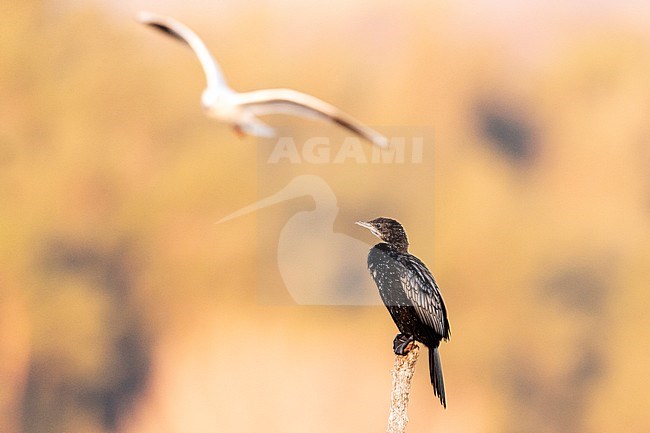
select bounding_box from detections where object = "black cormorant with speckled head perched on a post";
[357,217,450,407]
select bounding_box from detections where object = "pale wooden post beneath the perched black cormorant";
[386,344,420,433]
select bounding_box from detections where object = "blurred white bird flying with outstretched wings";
[138,11,388,147]
